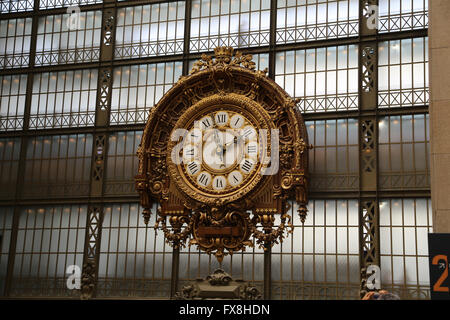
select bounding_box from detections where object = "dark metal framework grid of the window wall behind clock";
[0,0,431,299]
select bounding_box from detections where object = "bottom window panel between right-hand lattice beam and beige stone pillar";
[380,199,433,299]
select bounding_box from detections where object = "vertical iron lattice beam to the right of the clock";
[358,0,380,296]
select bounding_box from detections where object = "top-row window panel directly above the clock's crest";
[189,0,270,52]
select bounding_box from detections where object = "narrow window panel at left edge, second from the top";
[0,18,32,69]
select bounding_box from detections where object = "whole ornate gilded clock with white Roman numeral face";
[136,47,309,261]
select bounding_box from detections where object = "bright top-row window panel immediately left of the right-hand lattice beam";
[276,0,359,43]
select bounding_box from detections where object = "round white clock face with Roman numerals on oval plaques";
[180,108,259,194]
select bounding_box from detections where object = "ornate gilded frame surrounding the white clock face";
[135,47,311,262]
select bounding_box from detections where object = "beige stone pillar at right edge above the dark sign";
[429,0,450,233]
